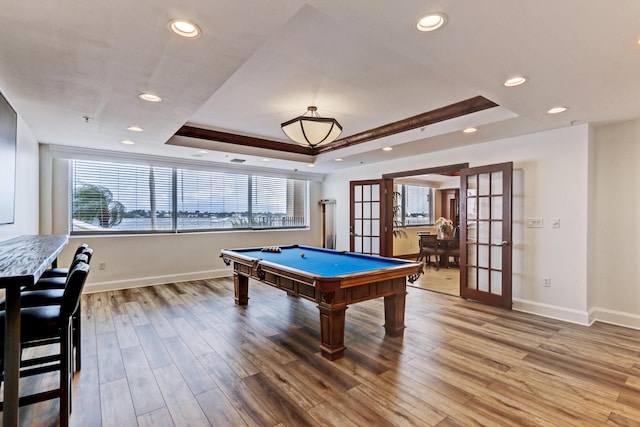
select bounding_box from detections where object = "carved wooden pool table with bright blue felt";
[220,245,422,360]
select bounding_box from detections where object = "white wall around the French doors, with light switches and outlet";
[323,125,589,324]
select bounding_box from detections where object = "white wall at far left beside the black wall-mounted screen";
[0,114,39,241]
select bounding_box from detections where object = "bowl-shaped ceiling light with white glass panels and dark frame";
[281,107,342,148]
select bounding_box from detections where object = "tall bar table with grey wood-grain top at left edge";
[0,234,69,426]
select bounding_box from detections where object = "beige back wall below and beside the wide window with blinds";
[40,154,322,292]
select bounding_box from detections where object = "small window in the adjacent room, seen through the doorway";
[395,184,434,227]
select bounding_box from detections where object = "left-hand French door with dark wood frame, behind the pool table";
[349,179,393,256]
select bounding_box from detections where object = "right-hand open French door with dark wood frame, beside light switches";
[460,162,513,309]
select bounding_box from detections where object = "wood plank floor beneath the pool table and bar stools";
[8,278,640,426]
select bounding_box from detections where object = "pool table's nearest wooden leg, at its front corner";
[318,292,347,360]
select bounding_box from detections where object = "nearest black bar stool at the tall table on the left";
[0,262,89,427]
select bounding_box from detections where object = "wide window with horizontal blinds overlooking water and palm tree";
[70,160,308,234]
